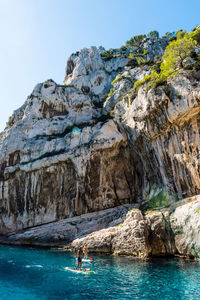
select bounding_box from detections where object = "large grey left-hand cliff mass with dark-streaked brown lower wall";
[0,80,134,233]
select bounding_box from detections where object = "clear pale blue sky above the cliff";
[0,0,200,131]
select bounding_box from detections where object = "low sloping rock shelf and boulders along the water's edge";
[0,196,200,259]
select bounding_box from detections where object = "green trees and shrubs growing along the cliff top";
[102,27,200,109]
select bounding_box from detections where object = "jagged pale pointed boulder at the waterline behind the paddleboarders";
[68,209,150,258]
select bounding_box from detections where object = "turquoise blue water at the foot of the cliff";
[0,246,200,300]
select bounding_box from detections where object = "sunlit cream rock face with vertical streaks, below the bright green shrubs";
[116,72,200,199]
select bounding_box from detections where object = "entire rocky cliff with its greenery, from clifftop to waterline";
[0,26,200,258]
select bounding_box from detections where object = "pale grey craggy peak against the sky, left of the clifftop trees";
[64,47,128,102]
